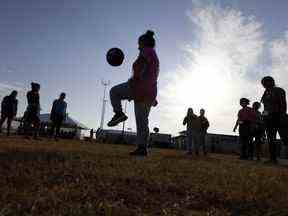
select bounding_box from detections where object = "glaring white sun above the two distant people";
[170,51,229,114]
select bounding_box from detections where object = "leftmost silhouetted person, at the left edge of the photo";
[0,91,18,136]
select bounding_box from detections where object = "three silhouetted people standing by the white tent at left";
[0,82,67,139]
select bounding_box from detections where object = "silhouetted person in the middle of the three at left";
[23,82,40,139]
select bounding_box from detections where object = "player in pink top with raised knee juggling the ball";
[108,30,159,156]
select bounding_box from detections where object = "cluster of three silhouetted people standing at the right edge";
[233,76,288,163]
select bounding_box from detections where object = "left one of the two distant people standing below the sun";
[183,108,200,155]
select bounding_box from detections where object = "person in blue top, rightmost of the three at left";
[50,92,67,140]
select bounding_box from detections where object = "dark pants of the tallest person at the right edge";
[265,113,287,161]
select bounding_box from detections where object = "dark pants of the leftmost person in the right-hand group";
[239,123,254,159]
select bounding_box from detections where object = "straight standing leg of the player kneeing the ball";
[134,102,151,154]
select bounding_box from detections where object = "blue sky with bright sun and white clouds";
[0,0,288,134]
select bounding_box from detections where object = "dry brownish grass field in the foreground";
[0,137,288,216]
